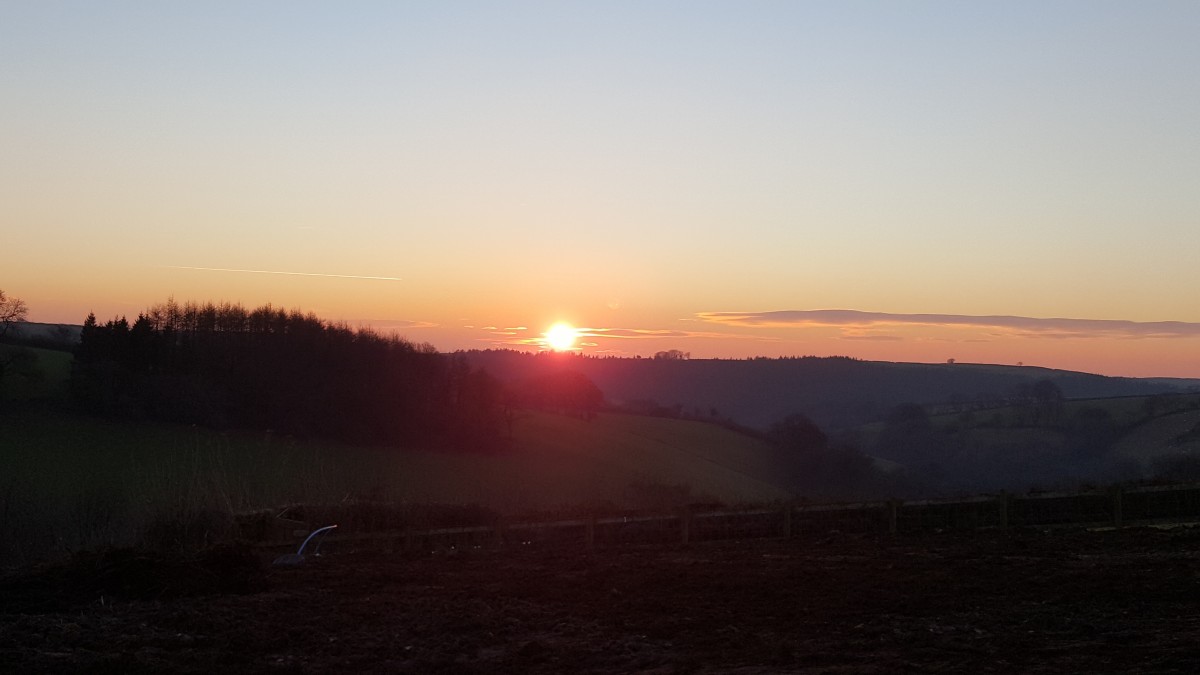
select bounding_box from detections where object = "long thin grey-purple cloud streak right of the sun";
[696,310,1200,339]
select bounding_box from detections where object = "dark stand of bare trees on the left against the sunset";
[71,300,505,449]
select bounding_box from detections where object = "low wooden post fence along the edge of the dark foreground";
[259,484,1200,551]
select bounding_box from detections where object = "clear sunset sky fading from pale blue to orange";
[0,0,1200,377]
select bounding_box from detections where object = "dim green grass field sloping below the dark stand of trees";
[0,406,790,563]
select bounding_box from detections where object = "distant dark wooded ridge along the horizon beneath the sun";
[466,351,1200,429]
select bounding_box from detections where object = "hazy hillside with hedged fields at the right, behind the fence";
[853,394,1200,490]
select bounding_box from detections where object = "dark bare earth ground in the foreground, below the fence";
[0,530,1200,674]
